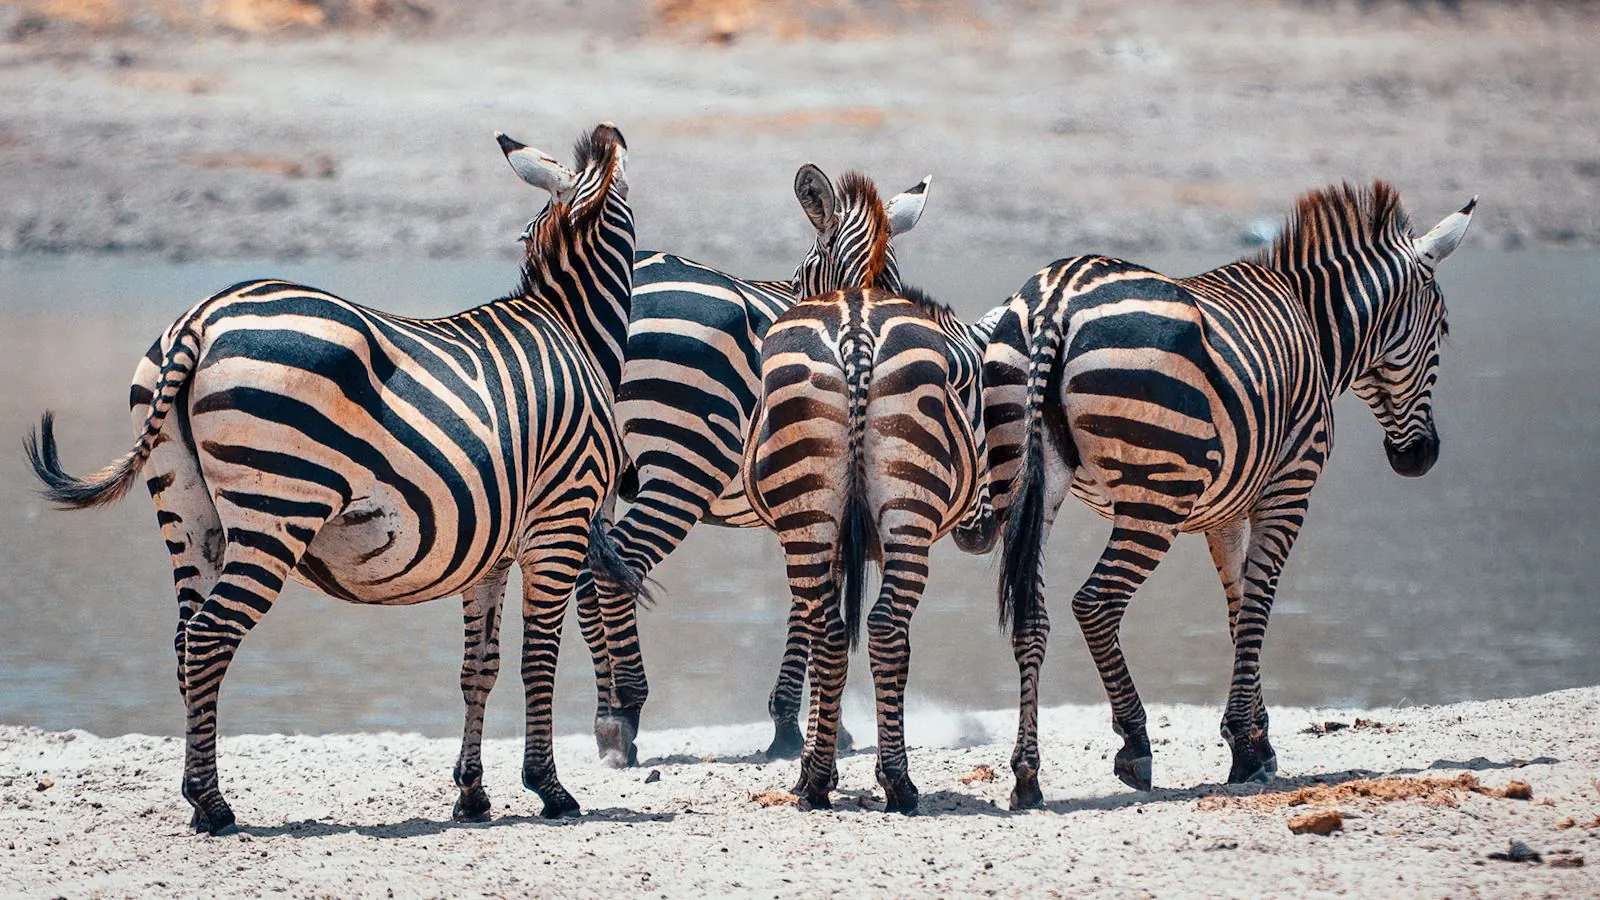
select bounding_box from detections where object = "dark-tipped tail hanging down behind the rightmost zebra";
[1000,309,1061,633]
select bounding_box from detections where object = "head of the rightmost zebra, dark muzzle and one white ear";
[1350,197,1478,477]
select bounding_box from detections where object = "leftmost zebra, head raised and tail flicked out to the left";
[26,123,634,834]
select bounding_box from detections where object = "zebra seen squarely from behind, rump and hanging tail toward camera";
[744,287,1003,814]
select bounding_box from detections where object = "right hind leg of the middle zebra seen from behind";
[867,530,928,815]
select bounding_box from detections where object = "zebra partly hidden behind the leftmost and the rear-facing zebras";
[578,163,933,765]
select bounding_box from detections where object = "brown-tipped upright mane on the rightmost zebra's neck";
[1254,179,1411,272]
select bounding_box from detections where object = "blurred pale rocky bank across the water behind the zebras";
[0,0,1600,265]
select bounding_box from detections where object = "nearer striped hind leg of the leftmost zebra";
[182,512,315,834]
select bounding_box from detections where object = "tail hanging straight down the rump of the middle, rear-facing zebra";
[835,325,877,650]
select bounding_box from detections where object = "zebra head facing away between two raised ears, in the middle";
[795,163,933,296]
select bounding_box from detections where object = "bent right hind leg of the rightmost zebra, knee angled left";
[1072,504,1182,791]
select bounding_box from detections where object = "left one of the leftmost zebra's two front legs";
[450,559,510,822]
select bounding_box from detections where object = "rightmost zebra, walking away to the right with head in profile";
[984,181,1477,809]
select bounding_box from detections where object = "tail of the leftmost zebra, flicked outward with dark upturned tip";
[22,303,206,509]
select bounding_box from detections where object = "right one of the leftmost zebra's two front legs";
[518,557,589,818]
